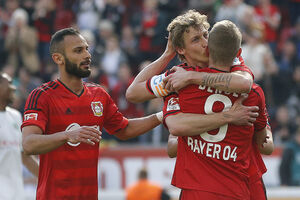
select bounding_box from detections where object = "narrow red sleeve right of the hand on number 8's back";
[253,86,268,132]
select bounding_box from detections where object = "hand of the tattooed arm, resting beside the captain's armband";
[163,66,190,92]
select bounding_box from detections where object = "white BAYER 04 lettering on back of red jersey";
[187,137,237,162]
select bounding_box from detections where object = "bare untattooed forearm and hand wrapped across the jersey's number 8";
[165,96,258,136]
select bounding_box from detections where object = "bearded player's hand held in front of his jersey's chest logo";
[66,126,102,145]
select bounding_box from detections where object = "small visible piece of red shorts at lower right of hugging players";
[249,179,267,200]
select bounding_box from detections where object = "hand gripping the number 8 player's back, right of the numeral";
[228,95,259,126]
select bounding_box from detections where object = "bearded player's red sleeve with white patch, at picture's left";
[21,87,49,133]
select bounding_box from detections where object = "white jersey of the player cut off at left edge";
[0,107,25,200]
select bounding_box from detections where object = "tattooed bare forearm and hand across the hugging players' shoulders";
[164,66,253,93]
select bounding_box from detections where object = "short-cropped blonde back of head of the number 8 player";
[208,20,242,65]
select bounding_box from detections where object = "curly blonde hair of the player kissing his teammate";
[167,10,210,61]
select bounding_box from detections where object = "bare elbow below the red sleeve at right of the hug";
[254,126,274,155]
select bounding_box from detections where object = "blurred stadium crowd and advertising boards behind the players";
[0,0,300,199]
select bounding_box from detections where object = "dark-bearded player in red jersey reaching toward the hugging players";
[21,28,162,200]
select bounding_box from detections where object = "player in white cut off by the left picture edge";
[0,73,39,200]
